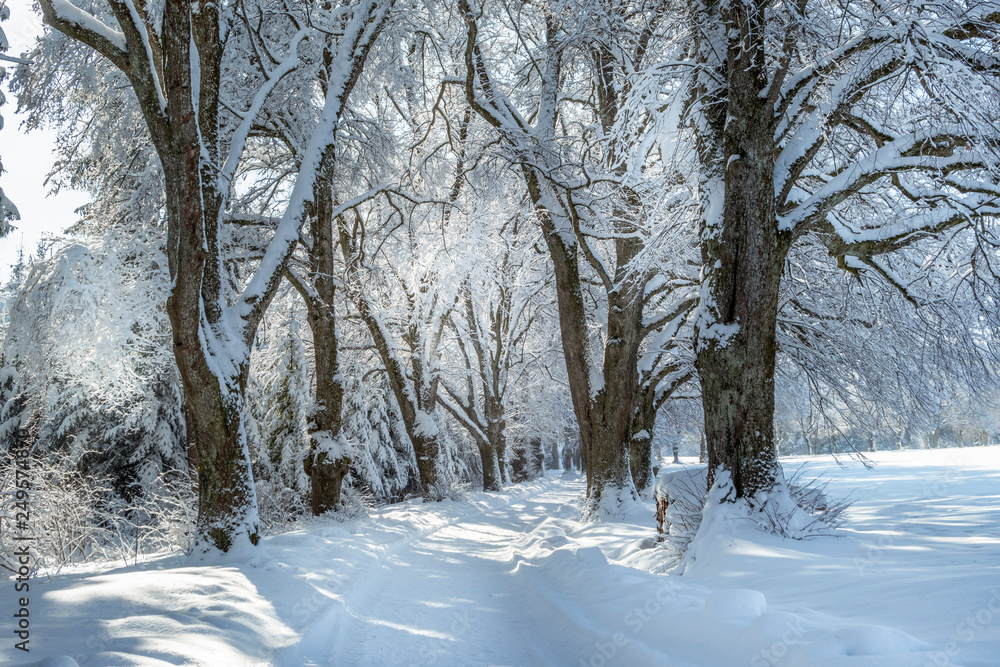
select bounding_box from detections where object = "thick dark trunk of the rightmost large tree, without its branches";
[694,2,787,505]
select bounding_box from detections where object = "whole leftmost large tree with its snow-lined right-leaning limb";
[24,0,391,551]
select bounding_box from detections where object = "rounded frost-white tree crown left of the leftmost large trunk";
[2,236,188,495]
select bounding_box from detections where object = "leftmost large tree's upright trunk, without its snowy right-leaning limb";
[157,2,260,551]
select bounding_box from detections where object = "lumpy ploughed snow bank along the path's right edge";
[512,482,933,667]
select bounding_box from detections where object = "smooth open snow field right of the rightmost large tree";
[683,447,1000,667]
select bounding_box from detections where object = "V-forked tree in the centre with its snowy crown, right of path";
[457,1,700,516]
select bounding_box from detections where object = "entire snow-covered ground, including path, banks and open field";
[0,447,1000,667]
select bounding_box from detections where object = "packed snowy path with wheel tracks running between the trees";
[275,487,579,667]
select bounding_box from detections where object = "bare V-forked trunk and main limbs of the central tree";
[459,9,644,515]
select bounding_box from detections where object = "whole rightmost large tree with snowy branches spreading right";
[640,0,1000,507]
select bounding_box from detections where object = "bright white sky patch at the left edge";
[0,0,87,281]
